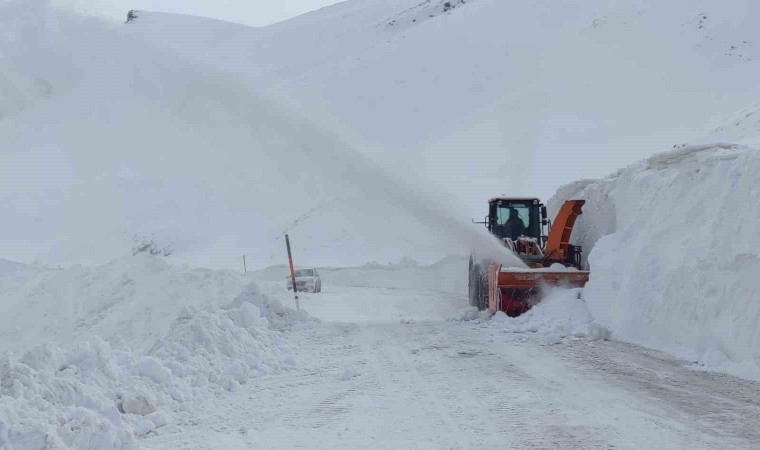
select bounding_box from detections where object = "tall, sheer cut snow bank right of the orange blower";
[550,145,760,378]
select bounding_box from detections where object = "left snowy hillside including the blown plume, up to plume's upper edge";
[0,2,524,268]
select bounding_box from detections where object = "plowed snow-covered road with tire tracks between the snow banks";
[143,286,760,449]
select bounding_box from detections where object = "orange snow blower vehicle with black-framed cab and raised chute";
[469,198,589,317]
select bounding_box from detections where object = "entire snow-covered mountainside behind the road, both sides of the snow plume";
[0,0,760,268]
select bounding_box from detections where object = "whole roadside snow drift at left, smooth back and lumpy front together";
[0,257,308,450]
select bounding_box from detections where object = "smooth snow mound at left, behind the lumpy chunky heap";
[0,255,251,352]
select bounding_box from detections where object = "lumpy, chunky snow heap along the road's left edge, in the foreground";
[0,272,303,449]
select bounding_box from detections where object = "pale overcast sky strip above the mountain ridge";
[51,0,339,26]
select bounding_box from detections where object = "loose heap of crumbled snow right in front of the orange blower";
[491,288,610,344]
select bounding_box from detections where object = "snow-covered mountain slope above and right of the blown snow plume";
[127,0,760,207]
